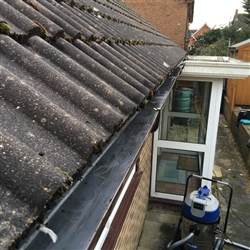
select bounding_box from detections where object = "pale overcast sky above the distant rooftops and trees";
[189,0,244,29]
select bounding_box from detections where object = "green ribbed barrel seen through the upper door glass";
[173,88,191,112]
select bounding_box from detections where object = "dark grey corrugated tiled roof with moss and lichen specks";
[0,0,185,249]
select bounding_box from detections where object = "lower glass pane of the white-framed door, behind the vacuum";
[155,148,203,195]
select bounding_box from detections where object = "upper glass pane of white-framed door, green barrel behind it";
[159,81,212,144]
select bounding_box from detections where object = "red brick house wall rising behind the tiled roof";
[124,0,192,49]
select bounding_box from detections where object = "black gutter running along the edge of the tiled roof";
[20,63,184,250]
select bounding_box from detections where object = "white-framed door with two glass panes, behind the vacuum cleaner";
[151,79,223,201]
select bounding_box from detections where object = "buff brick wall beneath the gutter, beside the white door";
[114,134,153,250]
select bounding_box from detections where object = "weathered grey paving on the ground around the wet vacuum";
[137,115,250,250]
